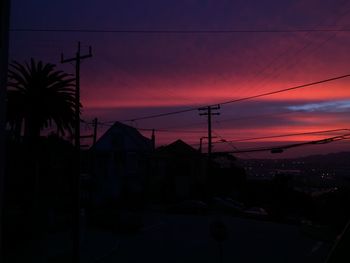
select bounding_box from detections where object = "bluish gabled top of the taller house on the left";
[91,122,152,152]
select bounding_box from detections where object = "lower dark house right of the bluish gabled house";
[148,140,207,202]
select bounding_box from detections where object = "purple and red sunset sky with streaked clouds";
[10,0,350,157]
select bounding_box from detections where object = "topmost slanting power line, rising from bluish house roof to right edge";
[122,74,350,122]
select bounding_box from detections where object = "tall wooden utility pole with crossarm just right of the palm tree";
[61,41,92,263]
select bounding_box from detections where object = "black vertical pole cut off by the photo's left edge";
[0,0,10,262]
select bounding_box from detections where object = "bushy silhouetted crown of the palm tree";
[7,59,75,137]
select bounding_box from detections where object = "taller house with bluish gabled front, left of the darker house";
[90,122,153,204]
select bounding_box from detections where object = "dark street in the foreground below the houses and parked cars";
[6,212,332,263]
